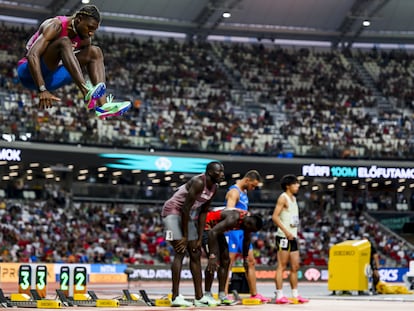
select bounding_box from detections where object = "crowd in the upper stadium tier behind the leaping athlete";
[0,25,413,159]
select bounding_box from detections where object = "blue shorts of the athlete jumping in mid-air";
[17,60,73,91]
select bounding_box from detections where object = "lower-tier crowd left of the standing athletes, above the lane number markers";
[0,198,168,264]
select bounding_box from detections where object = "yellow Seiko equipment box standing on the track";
[328,240,371,291]
